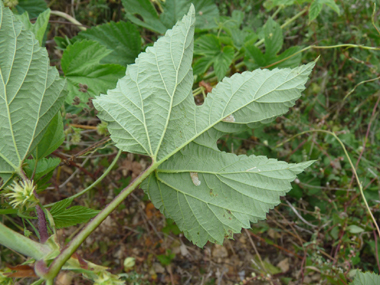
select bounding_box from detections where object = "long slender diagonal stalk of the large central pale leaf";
[46,163,159,280]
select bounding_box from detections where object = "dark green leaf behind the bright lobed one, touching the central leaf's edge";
[76,21,141,66]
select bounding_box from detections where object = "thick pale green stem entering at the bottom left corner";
[0,223,51,260]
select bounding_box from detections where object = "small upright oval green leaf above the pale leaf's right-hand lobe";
[264,18,284,57]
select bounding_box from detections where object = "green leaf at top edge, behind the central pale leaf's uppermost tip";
[122,0,219,34]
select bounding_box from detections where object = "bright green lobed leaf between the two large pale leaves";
[61,40,125,107]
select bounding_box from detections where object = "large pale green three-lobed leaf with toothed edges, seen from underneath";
[93,6,314,246]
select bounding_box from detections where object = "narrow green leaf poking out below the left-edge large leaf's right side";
[33,112,65,159]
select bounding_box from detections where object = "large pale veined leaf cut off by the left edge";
[0,2,66,177]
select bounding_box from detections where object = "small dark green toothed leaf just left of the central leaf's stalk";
[50,202,100,229]
